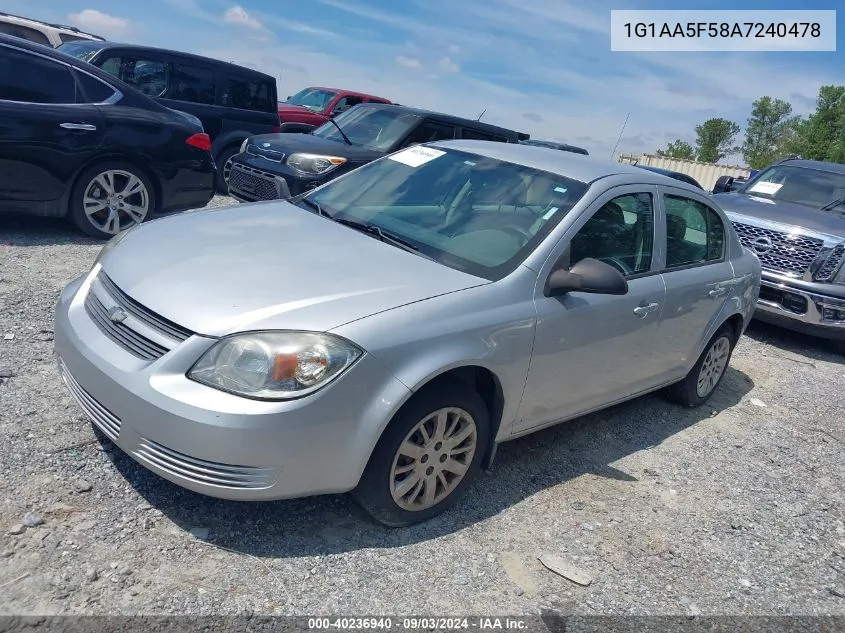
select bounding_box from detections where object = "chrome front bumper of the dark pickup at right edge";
[754,271,845,340]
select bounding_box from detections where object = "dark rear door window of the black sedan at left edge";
[0,46,76,104]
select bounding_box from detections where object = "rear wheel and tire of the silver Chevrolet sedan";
[666,323,736,408]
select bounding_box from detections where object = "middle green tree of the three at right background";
[742,97,801,169]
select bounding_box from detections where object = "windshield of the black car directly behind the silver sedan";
[311,105,419,152]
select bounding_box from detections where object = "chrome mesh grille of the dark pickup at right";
[733,222,824,277]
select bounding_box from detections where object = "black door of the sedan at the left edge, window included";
[0,44,103,214]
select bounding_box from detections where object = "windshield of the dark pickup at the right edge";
[740,165,845,213]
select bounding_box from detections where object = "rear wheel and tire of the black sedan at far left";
[69,161,156,240]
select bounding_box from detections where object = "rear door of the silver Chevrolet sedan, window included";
[656,187,734,378]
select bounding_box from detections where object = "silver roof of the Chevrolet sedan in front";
[426,139,712,188]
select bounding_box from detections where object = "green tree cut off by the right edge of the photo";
[790,86,845,163]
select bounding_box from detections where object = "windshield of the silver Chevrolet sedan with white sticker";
[302,145,589,281]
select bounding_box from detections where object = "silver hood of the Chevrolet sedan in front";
[100,201,489,336]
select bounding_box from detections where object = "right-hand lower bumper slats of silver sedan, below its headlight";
[134,437,279,488]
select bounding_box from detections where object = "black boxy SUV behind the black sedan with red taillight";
[58,42,279,193]
